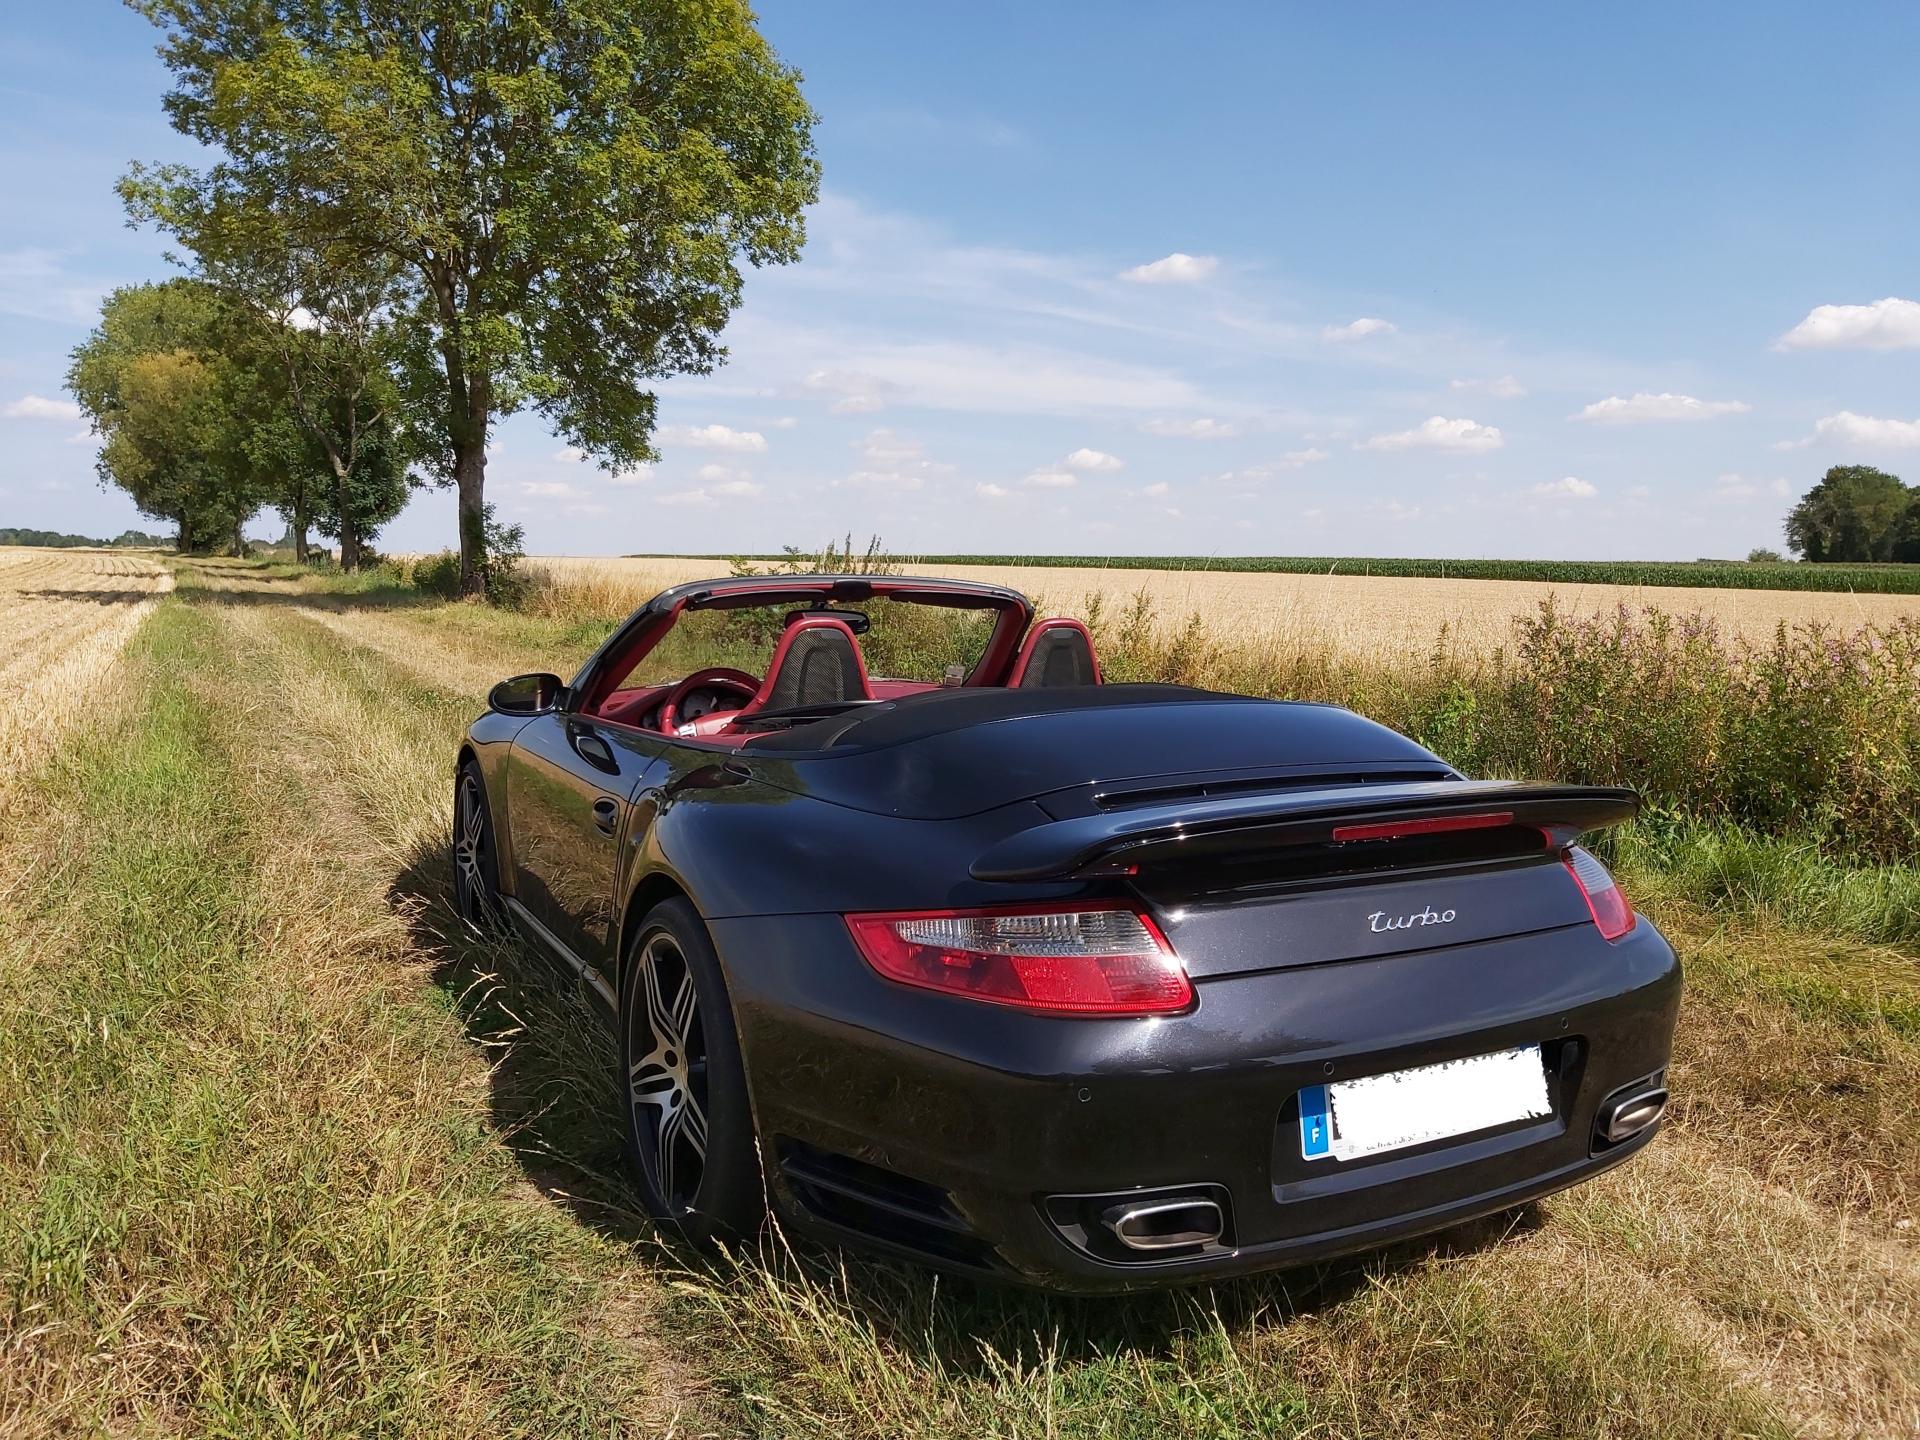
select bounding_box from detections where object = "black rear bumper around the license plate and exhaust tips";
[712,916,1680,1292]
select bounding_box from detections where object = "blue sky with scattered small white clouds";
[0,0,1920,559]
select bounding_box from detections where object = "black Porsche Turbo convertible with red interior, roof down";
[453,576,1680,1290]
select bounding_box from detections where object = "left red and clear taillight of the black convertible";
[847,904,1194,1016]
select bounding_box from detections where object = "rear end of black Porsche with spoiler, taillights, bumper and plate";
[714,695,1680,1290]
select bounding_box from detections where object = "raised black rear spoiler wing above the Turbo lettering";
[972,780,1640,881]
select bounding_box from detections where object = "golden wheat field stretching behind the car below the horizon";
[530,555,1920,660]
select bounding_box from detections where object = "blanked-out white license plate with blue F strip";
[1300,1044,1553,1160]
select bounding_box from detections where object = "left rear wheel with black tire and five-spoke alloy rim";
[620,899,766,1244]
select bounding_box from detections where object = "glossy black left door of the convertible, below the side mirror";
[507,710,664,979]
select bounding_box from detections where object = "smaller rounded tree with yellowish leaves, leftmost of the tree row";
[67,280,269,551]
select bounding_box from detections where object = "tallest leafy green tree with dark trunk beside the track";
[131,0,818,593]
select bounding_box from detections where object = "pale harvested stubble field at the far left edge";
[0,547,173,799]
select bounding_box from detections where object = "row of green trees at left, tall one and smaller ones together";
[73,0,818,593]
